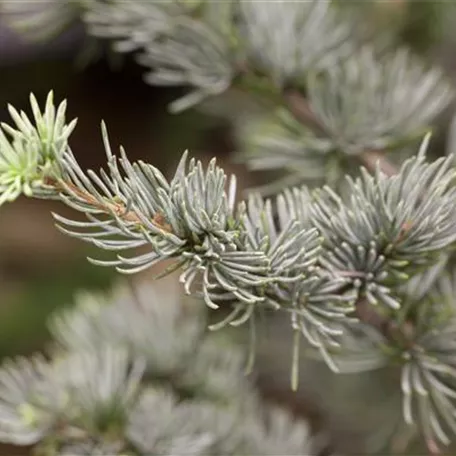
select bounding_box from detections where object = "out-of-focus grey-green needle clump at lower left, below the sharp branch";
[0,285,313,456]
